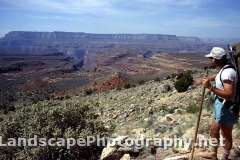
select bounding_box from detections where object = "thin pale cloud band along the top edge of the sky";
[0,0,209,15]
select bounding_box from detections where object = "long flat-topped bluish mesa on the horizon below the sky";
[0,31,206,55]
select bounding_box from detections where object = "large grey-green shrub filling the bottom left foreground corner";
[0,102,109,160]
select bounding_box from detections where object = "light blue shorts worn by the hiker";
[214,98,237,126]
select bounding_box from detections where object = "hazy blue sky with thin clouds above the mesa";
[0,0,240,38]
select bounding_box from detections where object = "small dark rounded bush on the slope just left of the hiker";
[174,71,193,92]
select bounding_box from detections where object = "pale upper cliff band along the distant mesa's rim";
[1,31,177,42]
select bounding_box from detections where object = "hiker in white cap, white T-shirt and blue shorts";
[195,47,238,160]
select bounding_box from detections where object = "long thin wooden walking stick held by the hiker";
[190,69,208,160]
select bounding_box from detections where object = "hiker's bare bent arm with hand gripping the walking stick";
[203,77,234,99]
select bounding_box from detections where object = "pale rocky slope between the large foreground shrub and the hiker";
[58,70,240,160]
